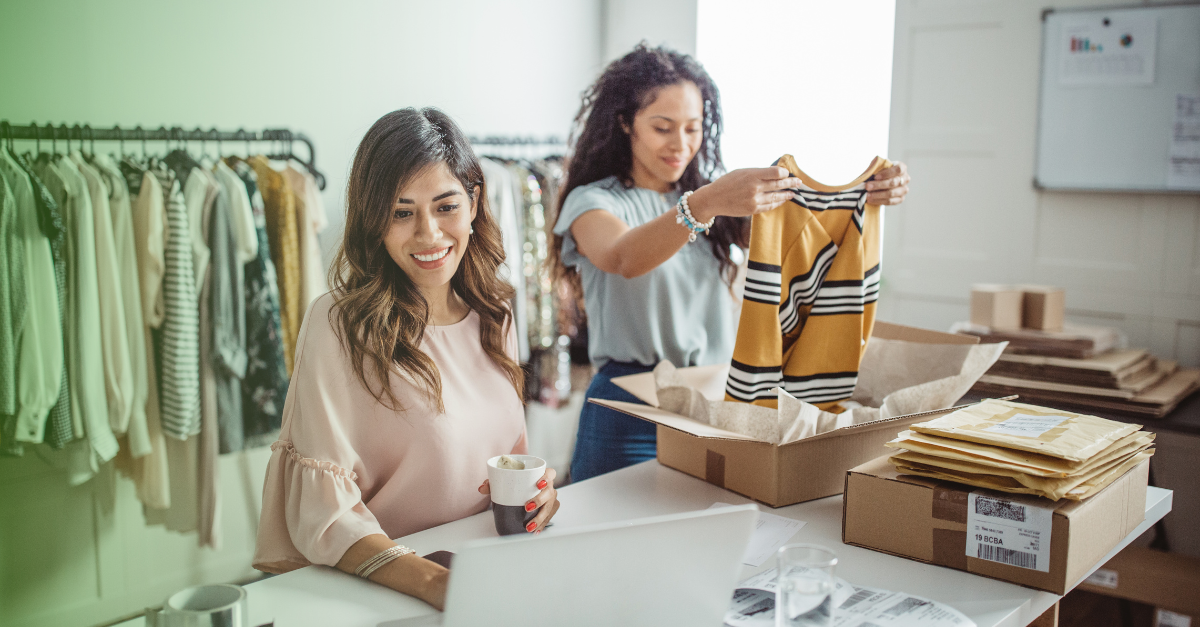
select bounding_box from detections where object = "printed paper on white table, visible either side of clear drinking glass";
[725,568,976,627]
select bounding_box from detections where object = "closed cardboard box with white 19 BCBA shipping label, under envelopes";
[841,455,1150,595]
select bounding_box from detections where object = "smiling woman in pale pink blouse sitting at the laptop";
[254,108,558,609]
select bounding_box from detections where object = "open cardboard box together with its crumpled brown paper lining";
[589,322,1003,507]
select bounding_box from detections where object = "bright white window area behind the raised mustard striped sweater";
[696,0,895,185]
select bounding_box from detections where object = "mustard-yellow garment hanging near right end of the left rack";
[247,155,304,374]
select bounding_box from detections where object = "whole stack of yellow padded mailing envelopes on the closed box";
[887,400,1154,501]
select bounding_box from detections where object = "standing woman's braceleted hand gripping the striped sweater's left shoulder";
[688,166,800,222]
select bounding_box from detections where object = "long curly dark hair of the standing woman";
[548,41,750,299]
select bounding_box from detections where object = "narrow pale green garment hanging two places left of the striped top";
[92,155,151,458]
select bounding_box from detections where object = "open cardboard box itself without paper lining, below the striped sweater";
[588,322,979,507]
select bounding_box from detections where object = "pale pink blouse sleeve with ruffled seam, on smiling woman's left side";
[253,294,384,573]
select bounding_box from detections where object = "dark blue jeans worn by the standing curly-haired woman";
[571,362,658,482]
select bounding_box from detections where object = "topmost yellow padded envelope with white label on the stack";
[912,400,1141,461]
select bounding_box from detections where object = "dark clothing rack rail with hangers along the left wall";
[0,120,325,190]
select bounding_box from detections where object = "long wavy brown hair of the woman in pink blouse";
[330,107,524,412]
